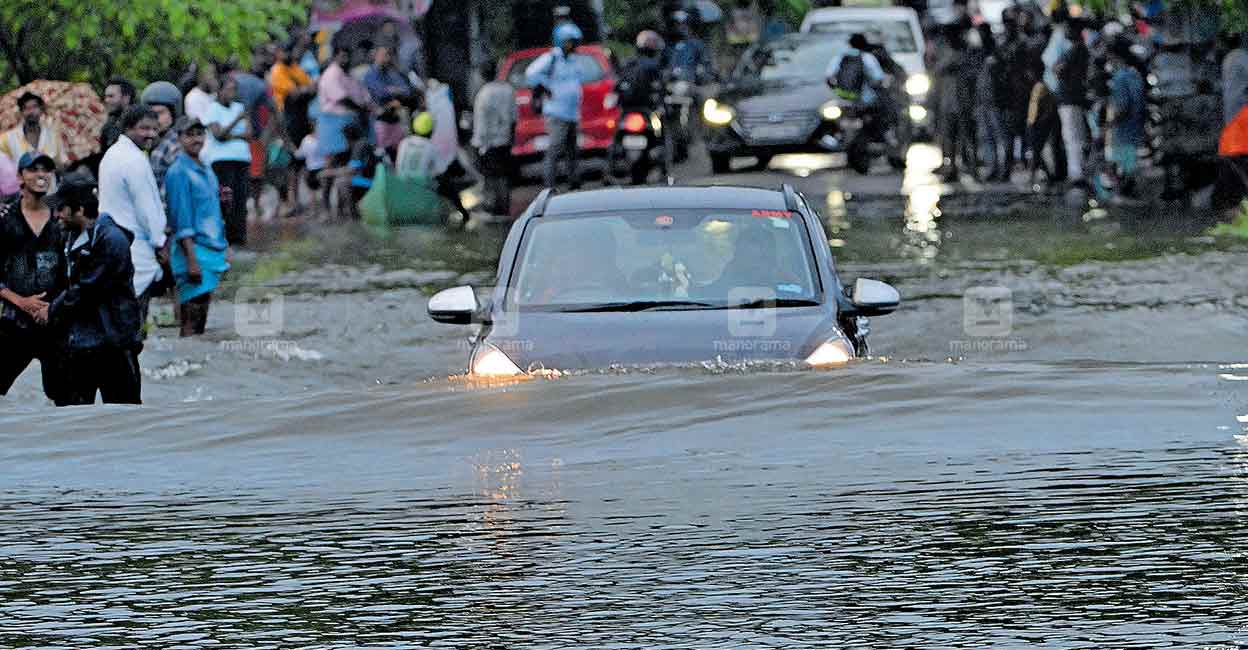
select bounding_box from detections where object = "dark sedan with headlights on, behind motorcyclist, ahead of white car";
[701,34,926,173]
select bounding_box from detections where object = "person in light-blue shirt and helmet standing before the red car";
[524,22,588,190]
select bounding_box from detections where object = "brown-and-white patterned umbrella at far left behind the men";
[0,80,109,160]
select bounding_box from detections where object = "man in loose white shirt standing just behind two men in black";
[99,105,168,322]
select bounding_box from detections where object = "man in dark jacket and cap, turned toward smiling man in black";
[35,174,142,407]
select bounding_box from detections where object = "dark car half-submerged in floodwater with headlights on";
[428,186,900,376]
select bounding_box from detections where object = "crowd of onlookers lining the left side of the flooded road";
[0,19,526,405]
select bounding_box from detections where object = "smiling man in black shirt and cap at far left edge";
[0,151,65,400]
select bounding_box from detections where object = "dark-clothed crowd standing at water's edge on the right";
[931,6,1248,200]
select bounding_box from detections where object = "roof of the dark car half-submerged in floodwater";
[543,185,786,215]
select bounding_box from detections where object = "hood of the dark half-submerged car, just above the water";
[485,306,844,369]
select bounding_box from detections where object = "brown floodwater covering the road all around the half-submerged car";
[0,149,1248,649]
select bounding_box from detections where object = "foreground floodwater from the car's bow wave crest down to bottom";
[0,363,1248,648]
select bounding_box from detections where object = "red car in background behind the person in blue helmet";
[498,45,620,160]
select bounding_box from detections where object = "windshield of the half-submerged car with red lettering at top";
[507,210,820,311]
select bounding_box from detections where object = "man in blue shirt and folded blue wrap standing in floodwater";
[165,116,230,337]
